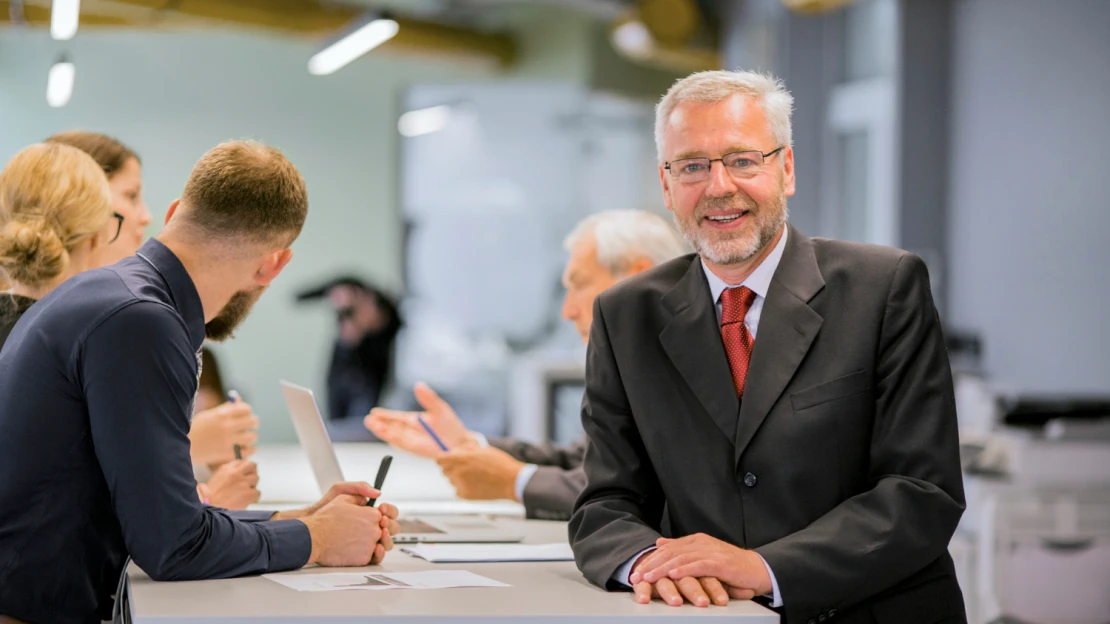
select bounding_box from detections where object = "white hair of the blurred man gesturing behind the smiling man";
[563,210,688,275]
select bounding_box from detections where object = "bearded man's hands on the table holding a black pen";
[271,482,401,567]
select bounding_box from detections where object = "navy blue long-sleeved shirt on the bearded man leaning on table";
[0,240,312,623]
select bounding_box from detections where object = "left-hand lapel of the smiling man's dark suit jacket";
[659,255,740,441]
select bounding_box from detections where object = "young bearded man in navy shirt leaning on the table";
[0,142,397,623]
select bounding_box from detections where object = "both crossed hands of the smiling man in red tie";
[628,533,771,607]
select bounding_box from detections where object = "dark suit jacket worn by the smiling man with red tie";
[569,228,965,624]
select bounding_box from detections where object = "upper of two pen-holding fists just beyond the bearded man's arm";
[189,401,259,465]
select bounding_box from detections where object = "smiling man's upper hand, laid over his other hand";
[629,533,771,602]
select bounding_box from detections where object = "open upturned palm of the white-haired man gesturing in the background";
[363,382,477,457]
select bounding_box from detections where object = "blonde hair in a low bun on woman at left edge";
[0,143,112,288]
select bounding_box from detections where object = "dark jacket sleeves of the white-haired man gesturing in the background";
[490,437,586,521]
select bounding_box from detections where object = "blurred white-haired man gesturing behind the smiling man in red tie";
[365,210,686,520]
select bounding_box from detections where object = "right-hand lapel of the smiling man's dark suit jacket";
[725,225,825,462]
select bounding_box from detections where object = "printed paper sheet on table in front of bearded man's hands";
[262,570,509,592]
